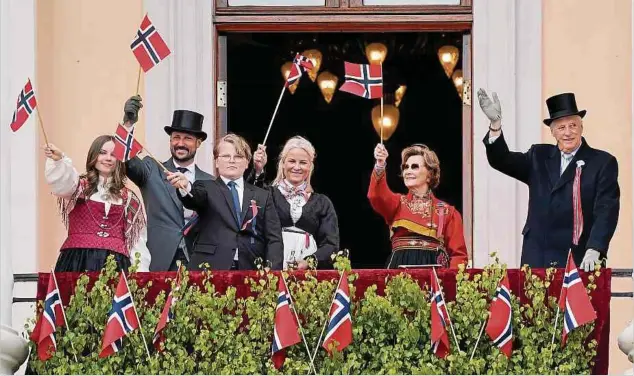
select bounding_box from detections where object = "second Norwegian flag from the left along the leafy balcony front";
[99,272,139,358]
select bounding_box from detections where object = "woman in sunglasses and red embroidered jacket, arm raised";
[368,144,468,268]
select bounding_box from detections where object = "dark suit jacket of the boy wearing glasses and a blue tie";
[178,178,284,270]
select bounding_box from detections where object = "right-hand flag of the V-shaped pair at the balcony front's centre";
[322,272,352,353]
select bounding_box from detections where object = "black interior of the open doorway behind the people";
[227,33,463,268]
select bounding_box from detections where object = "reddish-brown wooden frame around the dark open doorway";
[212,8,474,264]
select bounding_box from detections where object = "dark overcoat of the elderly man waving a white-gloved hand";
[483,134,620,268]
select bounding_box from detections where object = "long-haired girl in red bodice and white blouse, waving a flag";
[44,135,150,272]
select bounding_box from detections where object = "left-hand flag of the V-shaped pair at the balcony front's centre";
[271,276,301,369]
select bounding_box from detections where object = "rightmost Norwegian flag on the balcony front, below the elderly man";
[559,252,597,345]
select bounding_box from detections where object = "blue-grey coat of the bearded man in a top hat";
[126,157,212,272]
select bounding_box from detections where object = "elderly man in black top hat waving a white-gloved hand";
[478,89,620,271]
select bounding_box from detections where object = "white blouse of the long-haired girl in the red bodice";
[44,156,152,272]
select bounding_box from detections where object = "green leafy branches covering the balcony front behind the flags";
[26,257,599,374]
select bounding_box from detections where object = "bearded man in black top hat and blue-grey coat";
[123,96,213,271]
